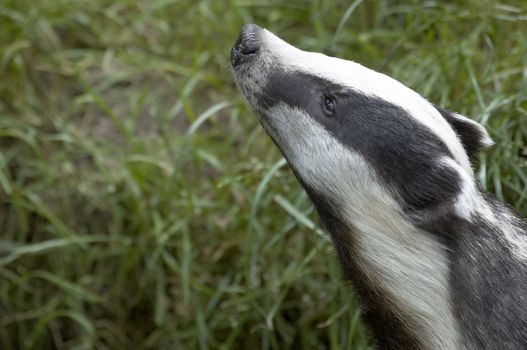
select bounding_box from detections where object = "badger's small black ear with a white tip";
[437,107,494,163]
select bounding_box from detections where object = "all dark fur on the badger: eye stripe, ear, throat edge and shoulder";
[234,32,527,350]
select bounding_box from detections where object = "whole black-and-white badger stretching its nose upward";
[230,24,527,350]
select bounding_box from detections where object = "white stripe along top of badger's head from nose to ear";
[262,30,473,175]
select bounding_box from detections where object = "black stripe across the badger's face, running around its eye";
[257,71,461,211]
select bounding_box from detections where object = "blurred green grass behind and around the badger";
[0,0,527,349]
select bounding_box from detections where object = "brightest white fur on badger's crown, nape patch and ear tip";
[261,30,500,226]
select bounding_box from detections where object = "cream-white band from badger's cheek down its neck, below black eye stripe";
[262,104,463,350]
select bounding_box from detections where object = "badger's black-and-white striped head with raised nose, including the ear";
[231,24,492,226]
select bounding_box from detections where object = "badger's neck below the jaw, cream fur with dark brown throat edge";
[308,190,463,349]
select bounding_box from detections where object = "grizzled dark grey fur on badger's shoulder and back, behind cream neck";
[450,193,527,350]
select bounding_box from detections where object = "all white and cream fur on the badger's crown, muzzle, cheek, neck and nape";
[235,25,527,350]
